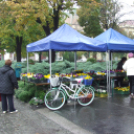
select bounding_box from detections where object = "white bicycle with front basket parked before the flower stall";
[44,77,95,110]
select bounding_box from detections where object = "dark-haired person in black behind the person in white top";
[115,57,127,87]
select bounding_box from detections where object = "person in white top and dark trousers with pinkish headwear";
[122,53,134,98]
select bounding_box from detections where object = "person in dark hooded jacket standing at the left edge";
[0,60,18,113]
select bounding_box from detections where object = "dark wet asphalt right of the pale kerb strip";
[53,95,134,134]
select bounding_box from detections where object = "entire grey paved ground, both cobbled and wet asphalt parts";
[0,95,134,134]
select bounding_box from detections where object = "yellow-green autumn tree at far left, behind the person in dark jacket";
[0,0,45,61]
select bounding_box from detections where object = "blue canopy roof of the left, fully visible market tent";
[27,24,107,52]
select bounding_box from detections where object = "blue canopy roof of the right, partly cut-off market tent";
[95,28,134,51]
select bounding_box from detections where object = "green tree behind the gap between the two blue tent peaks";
[77,0,124,37]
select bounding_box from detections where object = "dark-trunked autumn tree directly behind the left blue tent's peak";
[34,0,100,62]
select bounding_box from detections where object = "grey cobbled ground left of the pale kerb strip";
[0,99,72,134]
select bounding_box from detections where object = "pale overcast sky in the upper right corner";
[118,0,134,22]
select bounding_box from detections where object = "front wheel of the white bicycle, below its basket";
[44,89,65,110]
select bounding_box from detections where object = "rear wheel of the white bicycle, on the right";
[77,87,94,106]
